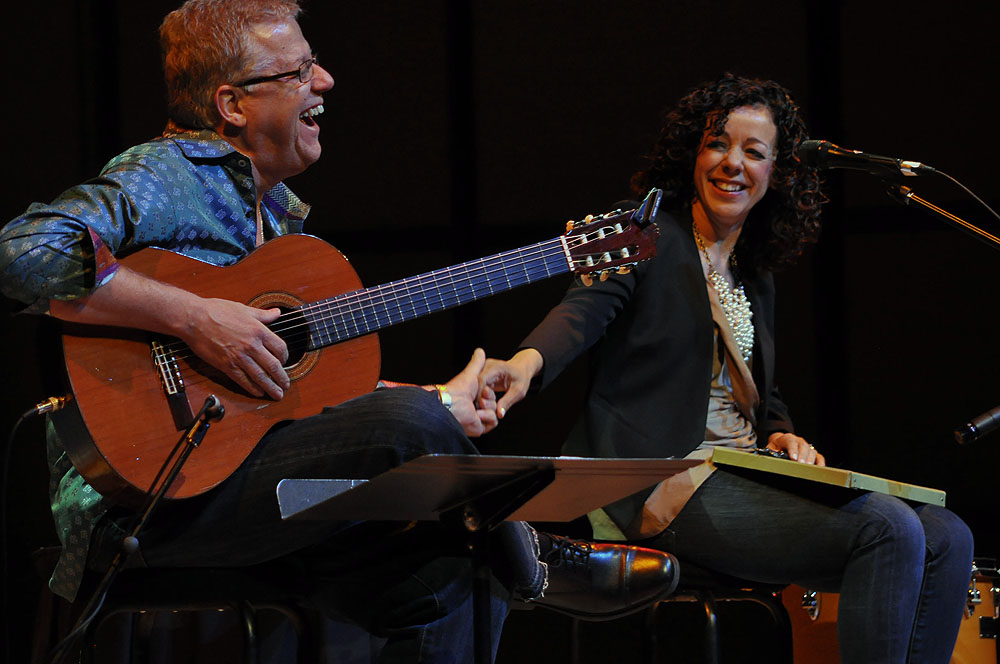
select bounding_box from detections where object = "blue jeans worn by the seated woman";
[654,470,973,664]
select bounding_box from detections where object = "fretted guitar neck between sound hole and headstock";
[295,238,570,350]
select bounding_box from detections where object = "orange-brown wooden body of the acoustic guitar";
[56,235,380,505]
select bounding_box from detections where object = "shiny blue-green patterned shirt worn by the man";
[0,126,309,601]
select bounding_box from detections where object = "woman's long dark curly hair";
[632,73,827,270]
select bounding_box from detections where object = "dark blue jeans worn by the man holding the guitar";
[95,387,510,664]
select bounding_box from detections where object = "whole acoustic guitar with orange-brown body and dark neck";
[53,190,659,505]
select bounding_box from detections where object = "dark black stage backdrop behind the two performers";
[0,0,1000,661]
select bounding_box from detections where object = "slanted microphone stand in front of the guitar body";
[49,394,226,664]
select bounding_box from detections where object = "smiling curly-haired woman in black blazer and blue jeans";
[480,70,972,664]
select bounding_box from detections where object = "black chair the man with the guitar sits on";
[32,547,321,664]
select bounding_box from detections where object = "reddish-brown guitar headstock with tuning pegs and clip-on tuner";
[563,189,663,286]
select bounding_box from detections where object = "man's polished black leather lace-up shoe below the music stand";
[533,533,680,620]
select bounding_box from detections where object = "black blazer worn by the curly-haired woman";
[521,212,793,527]
